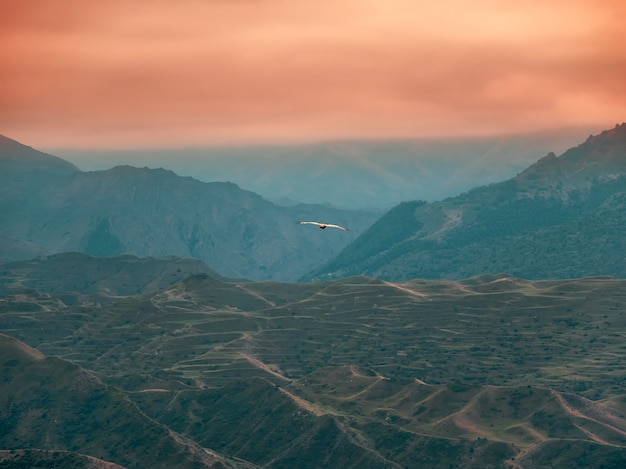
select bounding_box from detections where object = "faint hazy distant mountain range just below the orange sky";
[54,128,589,212]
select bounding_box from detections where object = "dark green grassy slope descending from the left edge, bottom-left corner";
[0,335,232,468]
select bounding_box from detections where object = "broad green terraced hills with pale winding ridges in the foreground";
[0,258,626,468]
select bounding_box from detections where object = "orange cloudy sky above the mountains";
[0,0,626,148]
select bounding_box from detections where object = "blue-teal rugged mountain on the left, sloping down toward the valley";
[0,138,378,280]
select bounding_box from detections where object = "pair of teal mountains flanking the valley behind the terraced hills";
[0,124,626,281]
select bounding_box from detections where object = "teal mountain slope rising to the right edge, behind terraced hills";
[304,124,626,280]
